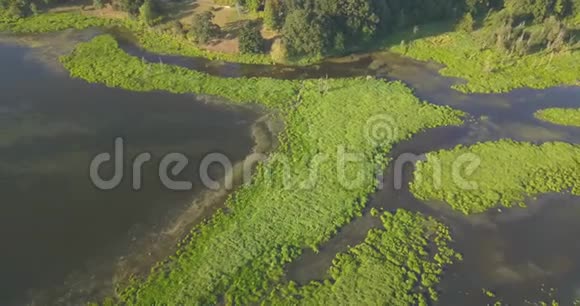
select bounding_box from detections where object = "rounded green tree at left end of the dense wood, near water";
[282,10,330,55]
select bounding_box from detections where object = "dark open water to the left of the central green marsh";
[0,38,258,305]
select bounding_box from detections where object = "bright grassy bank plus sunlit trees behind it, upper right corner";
[391,0,580,93]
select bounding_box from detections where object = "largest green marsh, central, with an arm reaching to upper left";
[62,36,461,305]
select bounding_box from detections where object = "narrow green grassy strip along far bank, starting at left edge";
[0,12,273,64]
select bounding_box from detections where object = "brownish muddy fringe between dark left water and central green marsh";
[27,101,283,304]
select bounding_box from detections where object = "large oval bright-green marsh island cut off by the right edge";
[411,140,580,214]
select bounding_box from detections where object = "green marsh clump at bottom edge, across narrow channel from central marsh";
[266,210,460,306]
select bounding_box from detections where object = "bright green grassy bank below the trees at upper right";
[391,30,580,93]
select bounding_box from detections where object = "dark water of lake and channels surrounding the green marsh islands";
[0,28,580,305]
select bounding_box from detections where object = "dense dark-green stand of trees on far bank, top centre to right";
[276,0,480,56]
